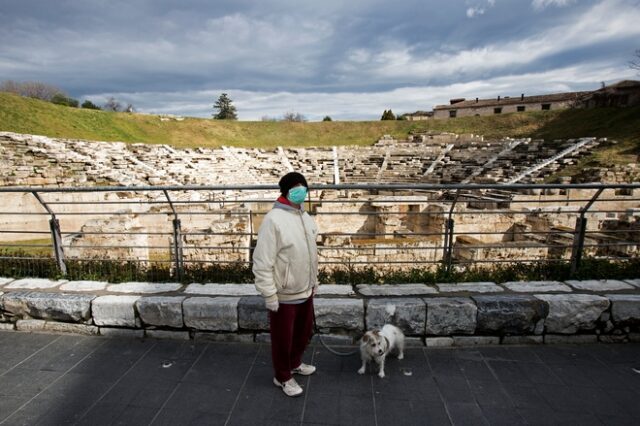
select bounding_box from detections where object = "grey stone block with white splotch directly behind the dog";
[366,299,427,335]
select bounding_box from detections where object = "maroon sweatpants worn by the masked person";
[269,297,313,383]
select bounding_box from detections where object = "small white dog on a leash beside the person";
[358,324,404,378]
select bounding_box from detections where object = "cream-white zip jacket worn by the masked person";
[253,201,318,302]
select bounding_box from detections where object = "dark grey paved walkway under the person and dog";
[0,332,640,426]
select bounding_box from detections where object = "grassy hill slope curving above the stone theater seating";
[0,93,640,165]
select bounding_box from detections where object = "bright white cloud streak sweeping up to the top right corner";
[341,1,640,80]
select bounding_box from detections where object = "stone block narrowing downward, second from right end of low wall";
[535,294,609,334]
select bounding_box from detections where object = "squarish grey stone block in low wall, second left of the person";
[182,297,240,331]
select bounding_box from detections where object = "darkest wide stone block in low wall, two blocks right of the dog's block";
[473,295,549,335]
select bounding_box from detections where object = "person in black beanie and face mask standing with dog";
[253,172,318,396]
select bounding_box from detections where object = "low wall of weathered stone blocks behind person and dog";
[0,278,640,346]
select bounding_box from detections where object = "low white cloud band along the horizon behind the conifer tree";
[88,62,634,121]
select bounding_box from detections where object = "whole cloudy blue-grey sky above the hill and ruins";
[0,0,640,120]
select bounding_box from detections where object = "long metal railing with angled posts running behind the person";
[0,184,640,279]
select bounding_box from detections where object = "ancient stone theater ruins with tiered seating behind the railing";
[0,132,640,267]
